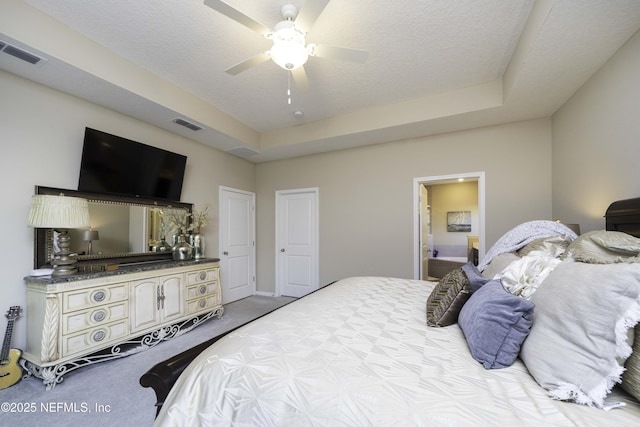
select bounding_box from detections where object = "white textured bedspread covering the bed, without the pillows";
[156,277,640,427]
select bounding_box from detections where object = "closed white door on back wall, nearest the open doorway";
[276,188,319,297]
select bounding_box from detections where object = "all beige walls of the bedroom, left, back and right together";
[0,28,640,347]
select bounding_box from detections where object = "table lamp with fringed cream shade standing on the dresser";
[29,194,90,276]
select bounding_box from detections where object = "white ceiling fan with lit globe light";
[204,0,369,91]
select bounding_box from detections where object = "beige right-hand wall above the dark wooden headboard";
[552,29,640,232]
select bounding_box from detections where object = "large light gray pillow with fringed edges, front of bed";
[520,260,640,408]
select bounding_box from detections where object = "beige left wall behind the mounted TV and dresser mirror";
[0,71,255,348]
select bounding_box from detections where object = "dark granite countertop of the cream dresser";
[24,258,220,285]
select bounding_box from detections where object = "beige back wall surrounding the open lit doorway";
[256,119,551,292]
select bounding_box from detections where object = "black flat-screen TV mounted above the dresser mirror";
[78,128,187,201]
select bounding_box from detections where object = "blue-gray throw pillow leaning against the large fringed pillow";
[458,280,534,369]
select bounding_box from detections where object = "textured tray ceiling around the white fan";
[0,0,640,161]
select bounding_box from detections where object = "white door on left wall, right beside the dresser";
[220,187,256,304]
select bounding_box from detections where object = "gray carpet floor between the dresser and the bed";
[0,295,294,427]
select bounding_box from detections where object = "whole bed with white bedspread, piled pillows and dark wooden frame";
[140,199,640,426]
